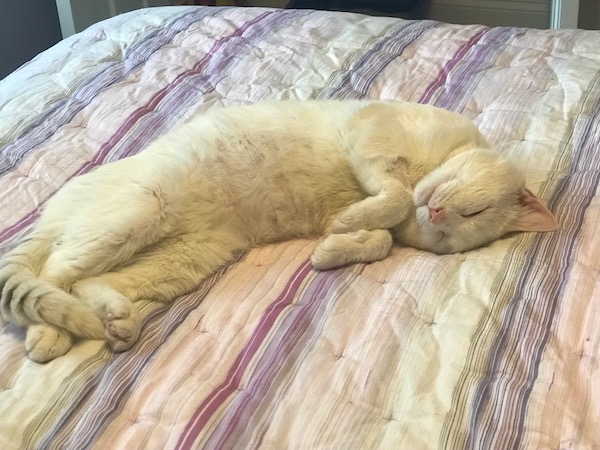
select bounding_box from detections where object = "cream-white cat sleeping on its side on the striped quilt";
[0,101,557,362]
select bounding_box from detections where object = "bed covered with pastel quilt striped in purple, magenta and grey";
[0,7,600,450]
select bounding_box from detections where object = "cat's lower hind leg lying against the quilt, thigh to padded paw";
[73,232,247,351]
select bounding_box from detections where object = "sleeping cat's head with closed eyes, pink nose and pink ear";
[394,148,558,254]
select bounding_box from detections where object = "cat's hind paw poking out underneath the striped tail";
[25,324,73,363]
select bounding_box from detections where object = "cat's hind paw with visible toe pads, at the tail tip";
[105,300,141,352]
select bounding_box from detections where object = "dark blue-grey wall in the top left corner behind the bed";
[0,0,61,79]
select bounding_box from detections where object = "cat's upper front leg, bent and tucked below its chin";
[331,156,414,233]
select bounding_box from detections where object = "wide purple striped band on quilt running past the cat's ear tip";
[467,74,600,449]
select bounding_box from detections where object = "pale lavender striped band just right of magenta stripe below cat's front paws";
[206,265,364,448]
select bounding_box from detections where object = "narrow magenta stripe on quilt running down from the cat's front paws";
[176,261,312,449]
